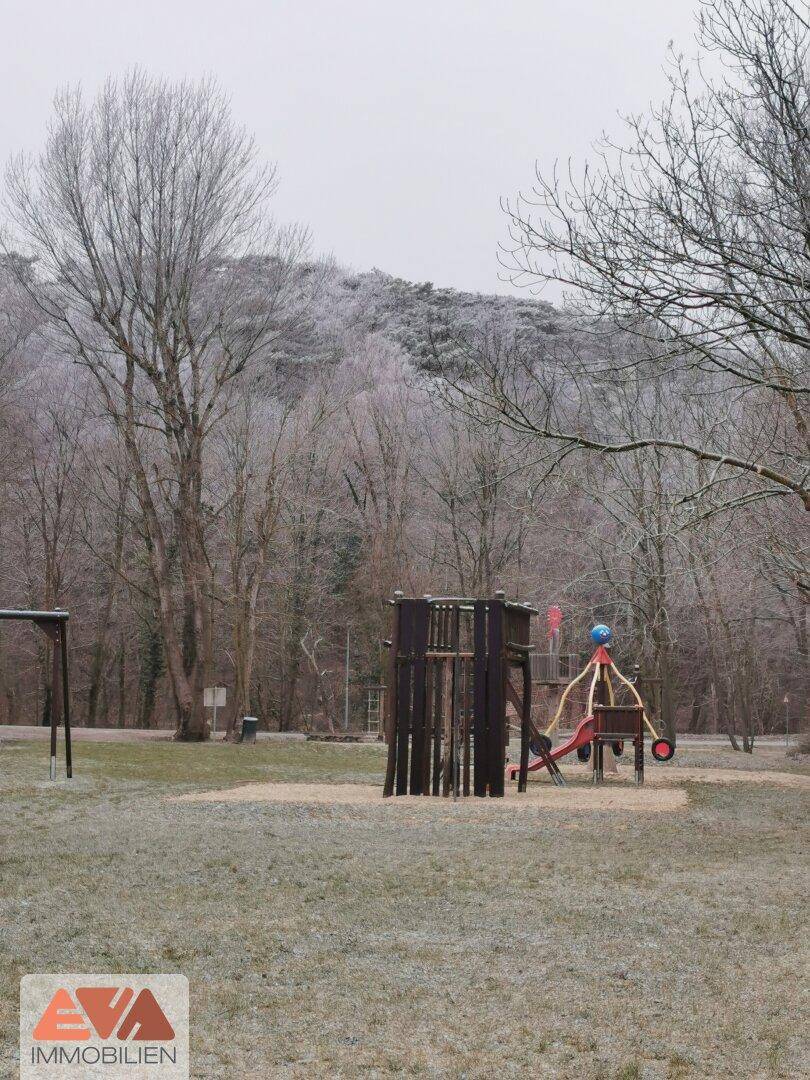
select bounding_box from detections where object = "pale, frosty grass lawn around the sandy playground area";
[0,742,810,1080]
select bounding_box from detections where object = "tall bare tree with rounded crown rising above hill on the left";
[6,71,303,739]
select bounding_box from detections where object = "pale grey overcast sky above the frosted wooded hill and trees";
[0,0,697,292]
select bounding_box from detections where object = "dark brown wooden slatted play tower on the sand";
[382,592,538,798]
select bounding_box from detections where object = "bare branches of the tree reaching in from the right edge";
[481,0,810,510]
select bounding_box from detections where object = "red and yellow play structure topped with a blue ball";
[507,623,675,784]
